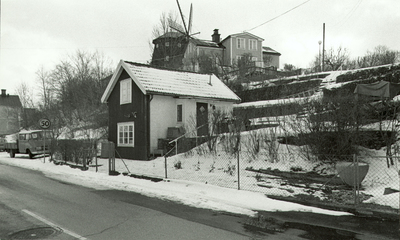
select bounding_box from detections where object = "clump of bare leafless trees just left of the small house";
[36,50,112,136]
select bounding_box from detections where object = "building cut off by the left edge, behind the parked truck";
[0,89,22,136]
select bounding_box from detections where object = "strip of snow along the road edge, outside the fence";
[0,152,349,219]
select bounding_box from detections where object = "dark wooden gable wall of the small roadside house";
[108,70,150,160]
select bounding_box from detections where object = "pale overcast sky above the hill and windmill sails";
[0,0,400,97]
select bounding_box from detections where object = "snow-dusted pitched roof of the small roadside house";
[101,60,240,103]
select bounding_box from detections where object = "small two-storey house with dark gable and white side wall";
[101,60,240,160]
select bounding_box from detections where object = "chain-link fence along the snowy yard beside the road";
[104,144,400,212]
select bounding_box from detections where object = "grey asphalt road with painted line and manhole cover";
[0,159,398,240]
